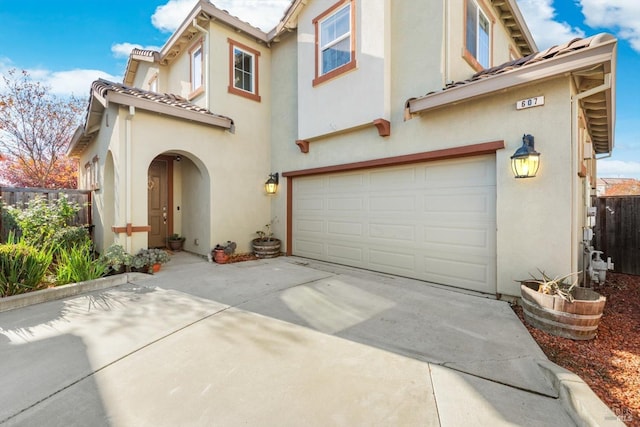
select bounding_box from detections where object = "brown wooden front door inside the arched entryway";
[147,159,169,248]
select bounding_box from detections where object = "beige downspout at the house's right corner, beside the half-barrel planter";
[571,73,611,278]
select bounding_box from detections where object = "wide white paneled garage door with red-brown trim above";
[292,155,496,293]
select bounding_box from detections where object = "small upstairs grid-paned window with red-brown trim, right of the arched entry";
[228,39,260,101]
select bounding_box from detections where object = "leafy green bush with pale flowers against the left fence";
[6,194,80,247]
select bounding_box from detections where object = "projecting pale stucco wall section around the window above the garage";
[297,0,391,139]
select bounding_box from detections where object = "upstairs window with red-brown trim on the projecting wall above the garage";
[313,0,356,86]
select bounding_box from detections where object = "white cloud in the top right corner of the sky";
[580,0,640,52]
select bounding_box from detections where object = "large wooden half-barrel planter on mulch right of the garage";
[520,281,606,340]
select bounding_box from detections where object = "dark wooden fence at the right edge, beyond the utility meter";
[595,196,640,275]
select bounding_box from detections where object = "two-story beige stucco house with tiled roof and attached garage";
[70,0,616,295]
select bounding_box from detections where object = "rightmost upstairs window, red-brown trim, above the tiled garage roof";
[465,0,491,70]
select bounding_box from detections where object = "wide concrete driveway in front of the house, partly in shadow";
[0,253,622,427]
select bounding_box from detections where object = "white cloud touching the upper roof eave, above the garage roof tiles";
[517,0,584,50]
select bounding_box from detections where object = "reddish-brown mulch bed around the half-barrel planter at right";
[514,273,640,426]
